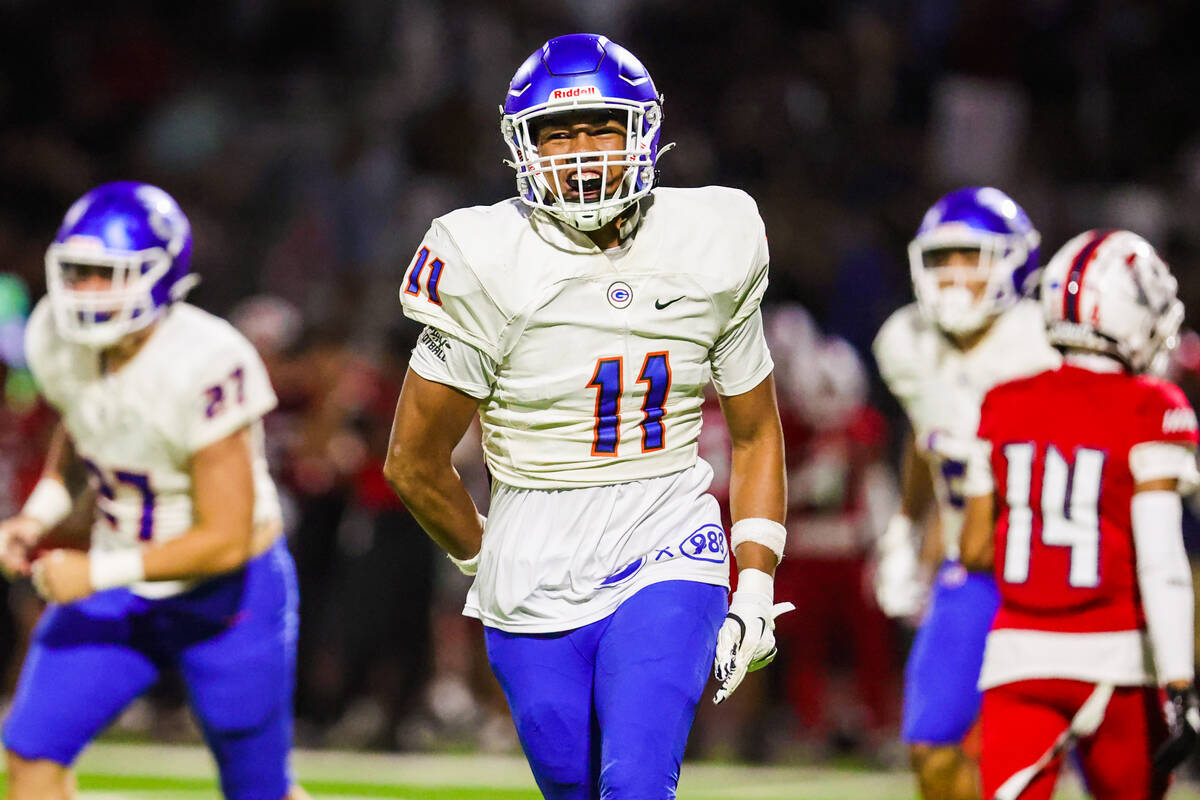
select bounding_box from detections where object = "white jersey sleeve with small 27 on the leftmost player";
[179,326,277,452]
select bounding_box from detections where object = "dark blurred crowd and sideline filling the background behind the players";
[0,0,1200,759]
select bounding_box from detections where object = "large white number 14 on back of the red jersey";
[1004,443,1104,589]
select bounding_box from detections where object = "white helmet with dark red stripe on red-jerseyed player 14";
[1042,230,1183,372]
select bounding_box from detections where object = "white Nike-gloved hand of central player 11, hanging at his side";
[713,570,796,703]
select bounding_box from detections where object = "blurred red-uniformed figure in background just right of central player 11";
[772,337,899,756]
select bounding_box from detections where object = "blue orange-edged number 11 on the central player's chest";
[588,351,671,456]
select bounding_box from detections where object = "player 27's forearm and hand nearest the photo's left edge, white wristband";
[0,422,74,576]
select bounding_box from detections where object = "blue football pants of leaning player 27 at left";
[2,539,298,800]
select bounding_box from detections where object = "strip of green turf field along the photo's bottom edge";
[9,742,1200,800]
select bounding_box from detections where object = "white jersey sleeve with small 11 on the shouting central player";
[400,219,508,361]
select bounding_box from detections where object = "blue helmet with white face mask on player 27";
[46,181,198,347]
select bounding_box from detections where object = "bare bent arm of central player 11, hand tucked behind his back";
[383,369,484,573]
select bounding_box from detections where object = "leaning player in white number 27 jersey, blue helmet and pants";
[0,182,304,800]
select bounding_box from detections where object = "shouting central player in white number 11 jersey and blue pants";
[385,34,785,800]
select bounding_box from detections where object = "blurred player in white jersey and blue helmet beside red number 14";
[874,187,1058,800]
